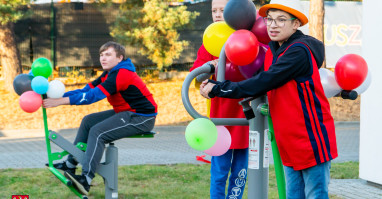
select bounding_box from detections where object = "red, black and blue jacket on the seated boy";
[64,59,157,116]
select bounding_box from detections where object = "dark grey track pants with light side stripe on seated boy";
[68,110,155,178]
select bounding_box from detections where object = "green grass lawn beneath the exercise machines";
[0,162,358,199]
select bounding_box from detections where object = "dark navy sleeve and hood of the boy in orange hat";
[208,30,325,98]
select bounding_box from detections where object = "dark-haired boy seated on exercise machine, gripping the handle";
[43,42,157,195]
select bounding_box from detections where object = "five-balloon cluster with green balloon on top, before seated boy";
[13,57,65,113]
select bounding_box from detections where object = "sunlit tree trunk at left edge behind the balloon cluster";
[0,23,22,92]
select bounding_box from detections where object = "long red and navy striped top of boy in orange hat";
[209,31,338,170]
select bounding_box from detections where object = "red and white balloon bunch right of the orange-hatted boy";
[319,54,371,98]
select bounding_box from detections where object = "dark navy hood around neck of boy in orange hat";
[269,30,325,68]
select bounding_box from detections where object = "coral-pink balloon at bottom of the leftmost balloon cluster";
[19,91,42,113]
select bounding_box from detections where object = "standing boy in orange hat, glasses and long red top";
[200,0,338,199]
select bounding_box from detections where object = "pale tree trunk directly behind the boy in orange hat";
[309,0,325,68]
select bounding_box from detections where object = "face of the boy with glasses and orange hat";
[267,10,300,46]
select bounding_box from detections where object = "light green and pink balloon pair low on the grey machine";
[185,118,231,156]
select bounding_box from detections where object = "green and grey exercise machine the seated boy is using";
[42,103,155,199]
